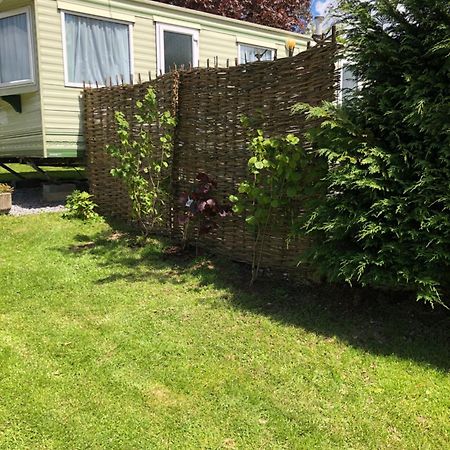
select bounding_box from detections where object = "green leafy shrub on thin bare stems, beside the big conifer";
[230,118,316,283]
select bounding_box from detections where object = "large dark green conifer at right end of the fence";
[300,0,450,303]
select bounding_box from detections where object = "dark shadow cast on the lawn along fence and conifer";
[63,231,450,372]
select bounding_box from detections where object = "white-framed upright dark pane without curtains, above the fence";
[156,23,199,73]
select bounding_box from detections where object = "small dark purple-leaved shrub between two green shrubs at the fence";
[178,172,231,250]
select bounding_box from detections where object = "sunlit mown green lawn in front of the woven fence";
[0,215,450,449]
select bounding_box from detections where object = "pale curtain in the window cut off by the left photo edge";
[0,13,31,83]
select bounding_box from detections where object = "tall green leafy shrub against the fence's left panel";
[106,88,175,235]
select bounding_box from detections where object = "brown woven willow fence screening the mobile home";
[84,43,338,271]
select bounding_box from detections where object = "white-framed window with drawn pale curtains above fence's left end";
[65,14,131,84]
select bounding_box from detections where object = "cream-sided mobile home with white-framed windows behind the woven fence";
[0,0,309,160]
